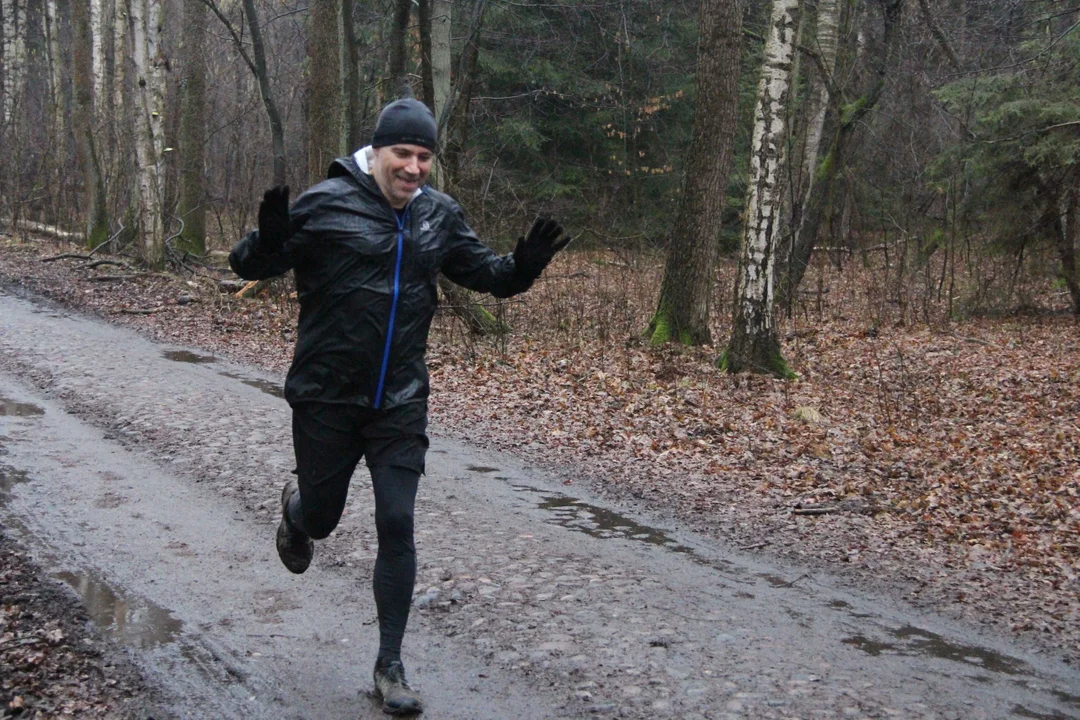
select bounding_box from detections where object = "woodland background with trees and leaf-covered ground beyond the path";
[0,0,1080,655]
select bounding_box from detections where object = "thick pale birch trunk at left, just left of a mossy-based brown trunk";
[132,0,165,268]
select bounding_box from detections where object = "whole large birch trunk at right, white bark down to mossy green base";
[720,0,799,378]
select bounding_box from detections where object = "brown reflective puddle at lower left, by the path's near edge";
[53,572,184,649]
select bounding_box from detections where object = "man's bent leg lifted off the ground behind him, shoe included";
[278,403,363,573]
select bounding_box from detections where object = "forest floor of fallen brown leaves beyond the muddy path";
[0,236,1080,717]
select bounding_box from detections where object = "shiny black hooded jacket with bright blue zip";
[229,148,531,408]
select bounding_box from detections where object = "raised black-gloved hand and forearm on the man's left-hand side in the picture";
[229,186,310,280]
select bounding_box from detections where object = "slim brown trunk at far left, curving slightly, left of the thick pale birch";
[71,0,109,248]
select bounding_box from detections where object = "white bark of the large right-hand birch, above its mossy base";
[735,0,799,338]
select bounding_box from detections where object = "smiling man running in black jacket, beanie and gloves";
[229,98,569,715]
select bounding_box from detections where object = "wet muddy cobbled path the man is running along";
[0,290,1080,719]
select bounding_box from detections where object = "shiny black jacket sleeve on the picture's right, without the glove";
[442,204,535,298]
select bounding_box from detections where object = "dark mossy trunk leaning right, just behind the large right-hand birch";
[777,0,904,307]
